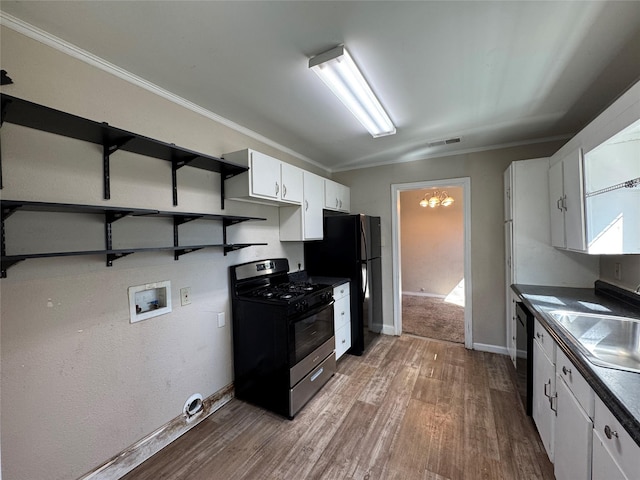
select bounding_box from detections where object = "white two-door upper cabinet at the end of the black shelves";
[223,149,303,205]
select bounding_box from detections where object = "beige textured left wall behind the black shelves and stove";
[0,27,313,480]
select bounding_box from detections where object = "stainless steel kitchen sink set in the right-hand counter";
[548,310,640,373]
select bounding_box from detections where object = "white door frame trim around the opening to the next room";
[391,177,473,349]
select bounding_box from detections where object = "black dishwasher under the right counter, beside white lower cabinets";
[516,302,533,416]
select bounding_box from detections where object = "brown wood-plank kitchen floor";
[123,336,554,480]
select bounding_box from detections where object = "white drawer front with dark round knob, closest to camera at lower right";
[593,397,640,478]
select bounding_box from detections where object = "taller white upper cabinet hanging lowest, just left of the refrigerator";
[280,171,324,242]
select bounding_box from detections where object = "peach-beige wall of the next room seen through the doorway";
[400,187,464,295]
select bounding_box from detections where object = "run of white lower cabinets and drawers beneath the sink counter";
[532,320,640,480]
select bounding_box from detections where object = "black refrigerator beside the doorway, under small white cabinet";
[304,215,382,355]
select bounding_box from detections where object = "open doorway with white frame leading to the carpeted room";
[391,178,473,348]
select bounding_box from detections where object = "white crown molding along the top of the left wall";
[0,11,330,172]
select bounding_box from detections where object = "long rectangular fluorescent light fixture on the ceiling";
[309,45,396,138]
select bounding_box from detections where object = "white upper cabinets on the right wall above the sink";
[549,77,640,254]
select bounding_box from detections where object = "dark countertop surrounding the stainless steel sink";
[511,285,640,446]
